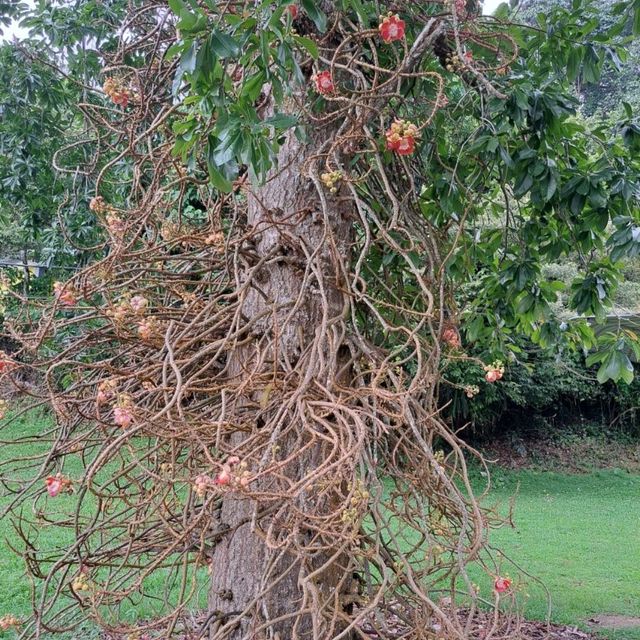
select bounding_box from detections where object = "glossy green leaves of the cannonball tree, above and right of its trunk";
[158,0,640,381]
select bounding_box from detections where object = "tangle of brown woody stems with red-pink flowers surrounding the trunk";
[0,0,516,640]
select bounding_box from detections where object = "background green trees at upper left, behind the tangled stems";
[0,2,134,270]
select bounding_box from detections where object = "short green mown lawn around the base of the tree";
[0,415,640,640]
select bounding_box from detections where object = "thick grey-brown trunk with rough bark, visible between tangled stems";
[210,115,353,640]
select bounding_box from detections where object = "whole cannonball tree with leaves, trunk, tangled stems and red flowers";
[2,0,639,640]
